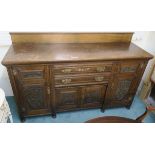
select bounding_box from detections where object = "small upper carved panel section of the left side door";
[13,66,45,80]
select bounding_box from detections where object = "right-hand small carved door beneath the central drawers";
[81,84,107,108]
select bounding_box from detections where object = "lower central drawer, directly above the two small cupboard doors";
[55,74,110,86]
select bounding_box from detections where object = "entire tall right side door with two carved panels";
[103,62,147,108]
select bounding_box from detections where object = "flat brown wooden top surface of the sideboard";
[2,42,153,65]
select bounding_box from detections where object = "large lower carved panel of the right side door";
[103,75,137,107]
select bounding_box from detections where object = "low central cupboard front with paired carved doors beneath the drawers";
[56,84,107,111]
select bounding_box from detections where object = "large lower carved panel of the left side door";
[21,84,50,115]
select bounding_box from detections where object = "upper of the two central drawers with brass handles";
[54,63,112,75]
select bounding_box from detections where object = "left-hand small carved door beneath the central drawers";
[55,87,80,111]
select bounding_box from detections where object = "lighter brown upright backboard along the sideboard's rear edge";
[11,33,133,43]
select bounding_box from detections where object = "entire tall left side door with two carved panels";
[13,66,50,116]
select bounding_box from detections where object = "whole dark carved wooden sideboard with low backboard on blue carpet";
[2,33,153,121]
